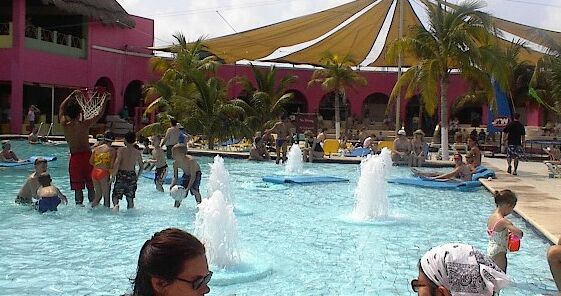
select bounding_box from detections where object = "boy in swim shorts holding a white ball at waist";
[170,144,202,208]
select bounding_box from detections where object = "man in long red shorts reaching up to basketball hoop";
[58,96,108,206]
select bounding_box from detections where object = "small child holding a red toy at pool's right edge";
[487,189,524,272]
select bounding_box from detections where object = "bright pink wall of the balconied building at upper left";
[0,0,157,132]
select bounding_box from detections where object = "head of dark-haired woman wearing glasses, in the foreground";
[132,228,212,296]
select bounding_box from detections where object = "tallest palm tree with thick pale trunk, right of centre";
[389,0,494,159]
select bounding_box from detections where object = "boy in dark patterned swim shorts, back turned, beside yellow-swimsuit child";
[111,132,142,212]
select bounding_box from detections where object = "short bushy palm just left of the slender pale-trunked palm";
[231,64,298,130]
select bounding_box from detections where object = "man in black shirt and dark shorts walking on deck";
[503,113,526,176]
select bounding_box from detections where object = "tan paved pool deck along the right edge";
[480,157,561,244]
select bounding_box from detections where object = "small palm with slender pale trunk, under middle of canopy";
[308,52,368,139]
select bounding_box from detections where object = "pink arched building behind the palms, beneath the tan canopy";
[219,65,545,132]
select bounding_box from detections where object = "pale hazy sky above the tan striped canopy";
[117,0,561,46]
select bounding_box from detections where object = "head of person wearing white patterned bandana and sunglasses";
[411,243,510,296]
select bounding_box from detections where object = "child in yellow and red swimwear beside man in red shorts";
[90,132,116,208]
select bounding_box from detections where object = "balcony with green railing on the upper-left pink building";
[25,25,87,58]
